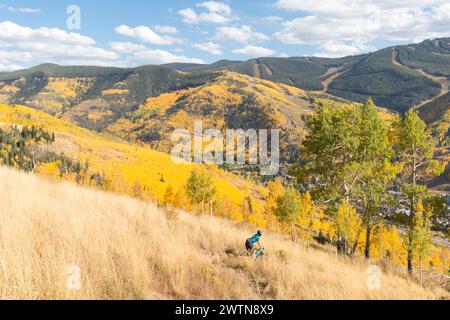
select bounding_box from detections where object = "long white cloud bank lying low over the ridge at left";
[0,22,204,71]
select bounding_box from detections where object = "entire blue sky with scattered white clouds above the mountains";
[0,0,450,71]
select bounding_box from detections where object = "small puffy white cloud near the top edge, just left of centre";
[178,1,232,24]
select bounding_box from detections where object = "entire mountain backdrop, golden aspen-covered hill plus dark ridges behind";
[0,38,450,189]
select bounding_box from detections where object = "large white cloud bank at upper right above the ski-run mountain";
[275,0,450,56]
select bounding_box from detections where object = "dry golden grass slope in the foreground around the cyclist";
[0,167,449,299]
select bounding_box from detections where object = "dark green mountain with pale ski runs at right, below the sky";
[167,38,450,121]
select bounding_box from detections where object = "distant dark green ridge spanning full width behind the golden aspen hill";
[0,38,450,122]
